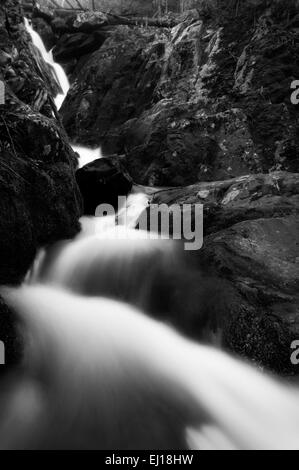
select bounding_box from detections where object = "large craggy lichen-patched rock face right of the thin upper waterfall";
[63,1,299,186]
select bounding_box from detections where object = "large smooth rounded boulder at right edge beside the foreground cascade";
[203,216,299,373]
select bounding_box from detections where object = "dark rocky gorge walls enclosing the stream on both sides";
[0,0,299,374]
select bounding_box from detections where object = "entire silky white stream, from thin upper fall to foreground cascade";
[7,17,299,450]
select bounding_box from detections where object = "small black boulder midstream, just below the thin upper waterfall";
[76,157,133,215]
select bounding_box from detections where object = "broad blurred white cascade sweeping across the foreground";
[0,286,299,450]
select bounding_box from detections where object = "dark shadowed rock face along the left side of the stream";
[0,0,81,362]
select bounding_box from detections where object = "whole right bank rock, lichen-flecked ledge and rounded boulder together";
[141,172,299,374]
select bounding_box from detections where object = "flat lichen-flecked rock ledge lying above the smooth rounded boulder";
[152,172,299,235]
